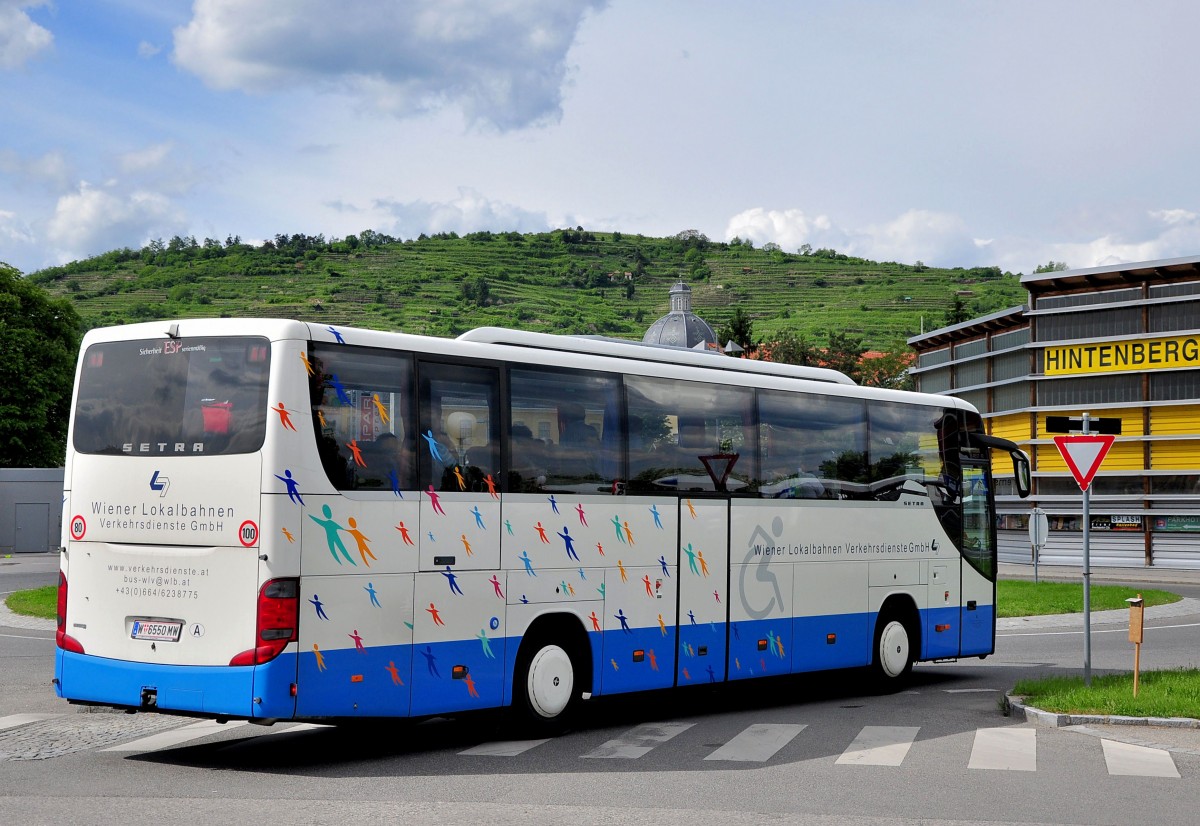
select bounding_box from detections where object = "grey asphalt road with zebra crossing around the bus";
[0,559,1200,826]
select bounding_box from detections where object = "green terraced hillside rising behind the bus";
[29,228,1025,348]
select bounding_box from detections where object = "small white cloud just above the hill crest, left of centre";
[376,188,552,238]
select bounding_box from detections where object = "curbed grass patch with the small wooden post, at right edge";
[1013,669,1200,718]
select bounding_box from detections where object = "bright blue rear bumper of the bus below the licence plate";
[55,650,295,719]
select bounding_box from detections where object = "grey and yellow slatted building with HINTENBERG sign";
[908,257,1200,568]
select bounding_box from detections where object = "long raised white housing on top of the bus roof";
[458,327,854,384]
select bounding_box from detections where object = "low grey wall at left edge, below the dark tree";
[0,467,62,556]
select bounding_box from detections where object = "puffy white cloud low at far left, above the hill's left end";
[46,181,187,262]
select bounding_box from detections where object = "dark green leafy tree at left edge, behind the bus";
[0,262,83,467]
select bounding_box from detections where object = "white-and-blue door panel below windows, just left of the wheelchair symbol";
[676,497,730,686]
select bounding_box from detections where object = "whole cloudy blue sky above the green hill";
[0,0,1200,273]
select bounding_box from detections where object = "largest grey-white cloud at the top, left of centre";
[174,0,604,130]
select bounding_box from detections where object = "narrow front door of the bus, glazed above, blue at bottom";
[959,462,996,657]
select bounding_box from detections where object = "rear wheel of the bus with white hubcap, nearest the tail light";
[512,638,582,734]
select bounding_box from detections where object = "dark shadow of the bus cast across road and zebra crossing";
[127,668,1020,778]
